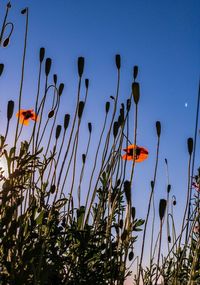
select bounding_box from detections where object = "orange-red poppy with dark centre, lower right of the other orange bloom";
[122,144,149,162]
